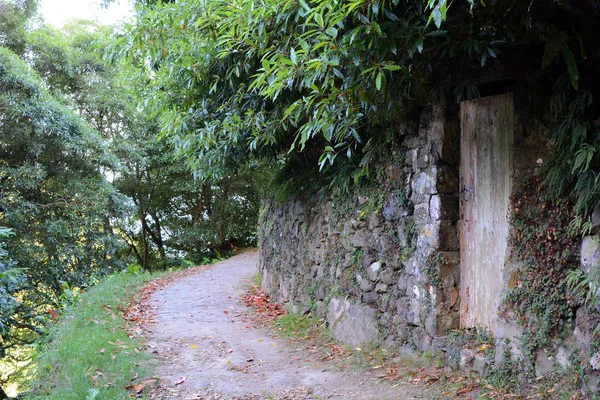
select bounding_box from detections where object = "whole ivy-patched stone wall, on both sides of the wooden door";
[259,95,600,386]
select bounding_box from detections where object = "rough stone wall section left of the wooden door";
[259,101,459,350]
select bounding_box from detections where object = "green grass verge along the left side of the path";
[26,274,156,400]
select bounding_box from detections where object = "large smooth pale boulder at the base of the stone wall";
[327,297,378,346]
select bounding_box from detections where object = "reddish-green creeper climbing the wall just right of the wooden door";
[505,177,578,357]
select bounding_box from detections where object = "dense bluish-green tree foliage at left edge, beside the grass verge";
[0,43,123,372]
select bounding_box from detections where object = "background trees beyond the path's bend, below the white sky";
[28,21,265,269]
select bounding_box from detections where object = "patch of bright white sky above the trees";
[40,0,133,28]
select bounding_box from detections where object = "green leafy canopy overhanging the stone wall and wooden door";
[111,0,600,216]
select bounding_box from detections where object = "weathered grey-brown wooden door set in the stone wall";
[460,93,514,332]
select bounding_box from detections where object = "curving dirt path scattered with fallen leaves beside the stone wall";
[147,252,432,400]
